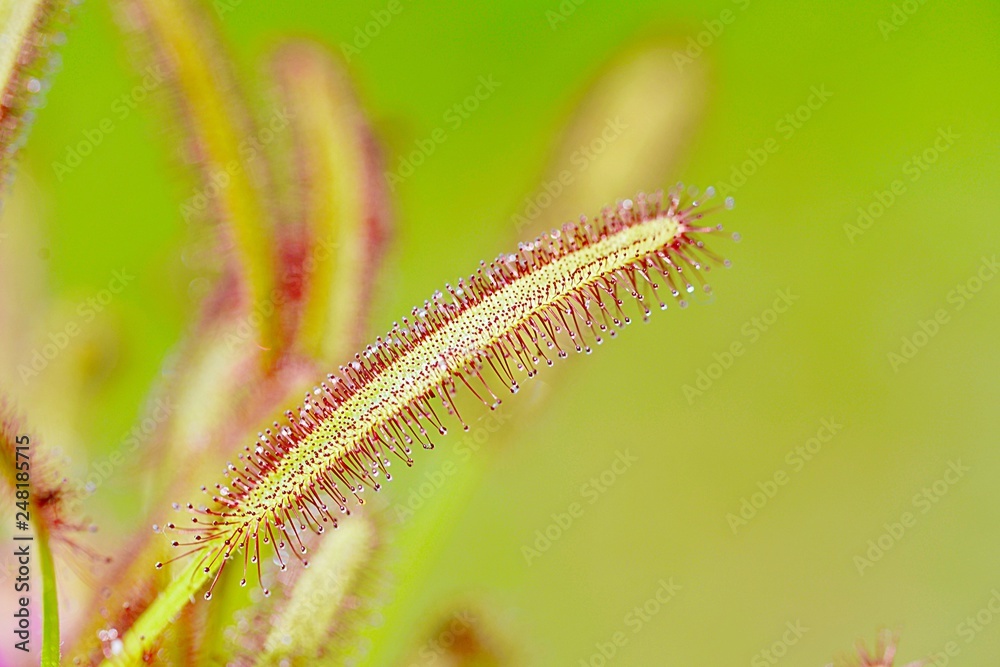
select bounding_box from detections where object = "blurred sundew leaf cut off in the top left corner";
[0,0,69,186]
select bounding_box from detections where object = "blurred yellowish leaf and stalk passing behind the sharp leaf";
[365,44,708,664]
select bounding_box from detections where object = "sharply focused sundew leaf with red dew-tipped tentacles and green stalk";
[101,188,731,665]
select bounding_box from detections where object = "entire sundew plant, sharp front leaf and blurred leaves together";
[0,0,916,666]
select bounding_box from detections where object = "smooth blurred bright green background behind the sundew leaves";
[7,0,1000,665]
